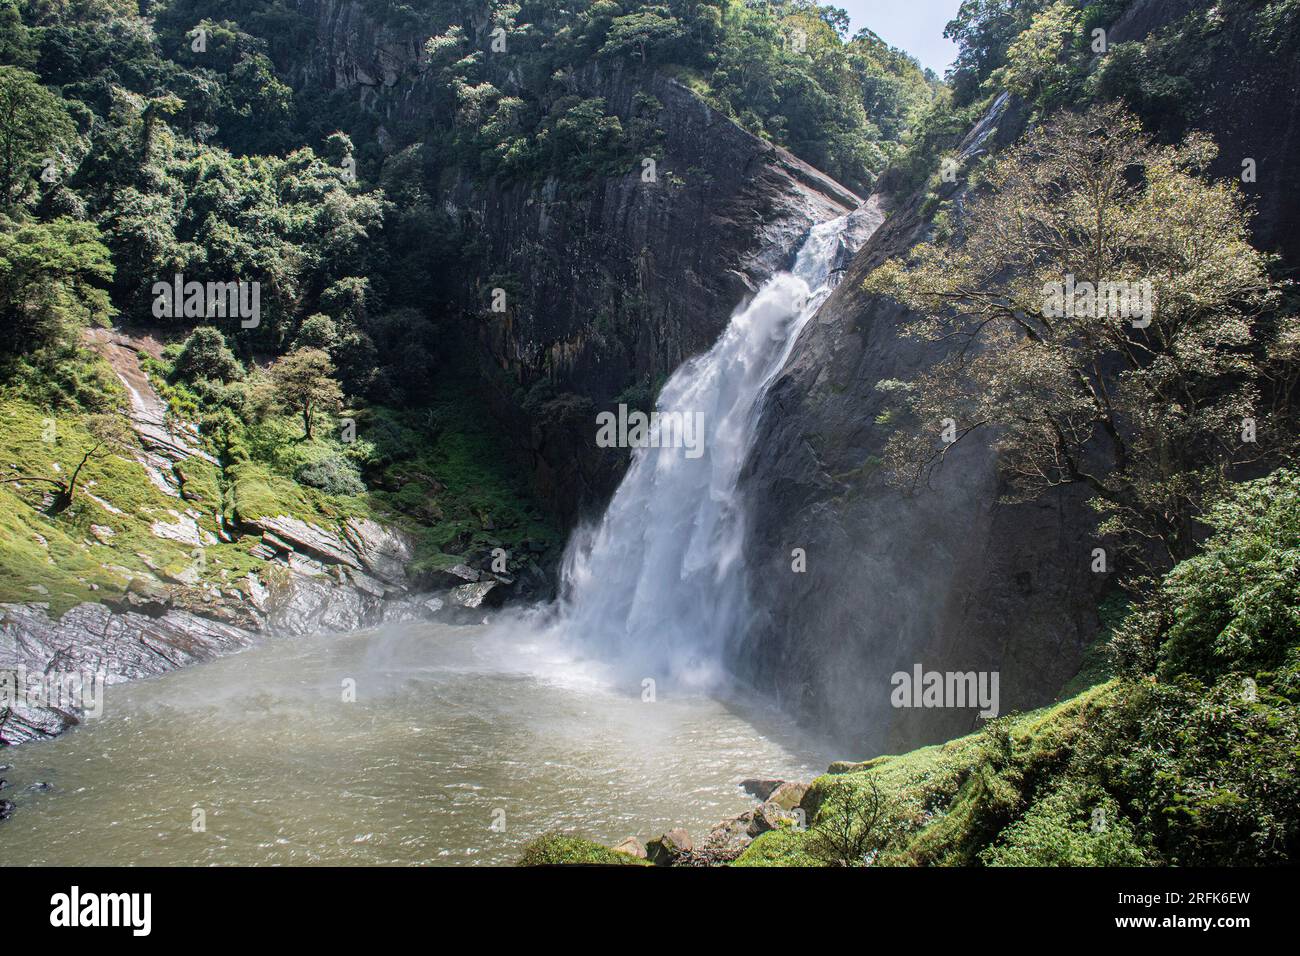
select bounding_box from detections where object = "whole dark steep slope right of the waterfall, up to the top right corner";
[735,1,1297,756]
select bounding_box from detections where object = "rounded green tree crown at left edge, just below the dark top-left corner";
[0,66,77,207]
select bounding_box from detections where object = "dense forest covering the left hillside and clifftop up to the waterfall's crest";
[0,0,939,606]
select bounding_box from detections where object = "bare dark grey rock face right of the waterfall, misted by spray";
[735,0,1300,756]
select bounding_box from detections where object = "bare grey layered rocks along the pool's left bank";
[0,345,473,745]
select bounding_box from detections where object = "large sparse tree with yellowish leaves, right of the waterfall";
[867,105,1278,566]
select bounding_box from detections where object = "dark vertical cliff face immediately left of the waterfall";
[286,0,861,520]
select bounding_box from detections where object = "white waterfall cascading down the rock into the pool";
[555,217,848,688]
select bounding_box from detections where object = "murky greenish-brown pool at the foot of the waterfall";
[0,626,831,865]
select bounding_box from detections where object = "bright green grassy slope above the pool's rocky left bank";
[0,338,560,617]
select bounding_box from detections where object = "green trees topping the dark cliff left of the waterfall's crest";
[410,0,935,190]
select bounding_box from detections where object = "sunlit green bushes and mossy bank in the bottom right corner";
[737,471,1300,866]
